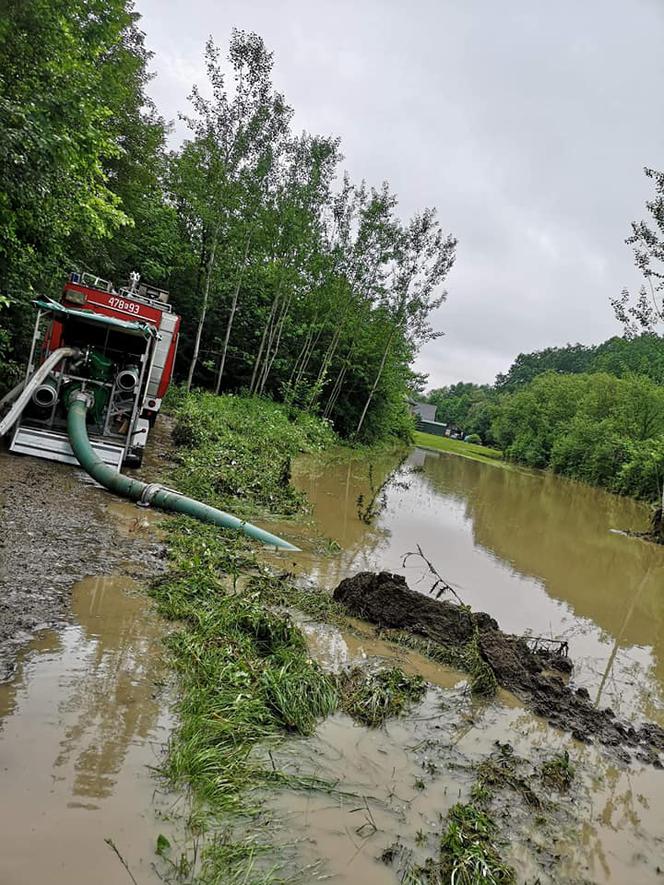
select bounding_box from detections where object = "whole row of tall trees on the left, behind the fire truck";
[0,0,456,440]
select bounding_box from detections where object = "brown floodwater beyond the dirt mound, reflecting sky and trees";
[276,450,664,720]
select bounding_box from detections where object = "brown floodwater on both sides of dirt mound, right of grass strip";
[260,449,664,885]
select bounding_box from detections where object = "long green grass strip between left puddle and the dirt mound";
[152,544,337,810]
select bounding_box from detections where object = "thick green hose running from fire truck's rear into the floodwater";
[67,390,299,551]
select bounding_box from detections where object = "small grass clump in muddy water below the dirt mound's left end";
[338,667,426,728]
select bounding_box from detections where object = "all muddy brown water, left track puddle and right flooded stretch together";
[0,450,664,885]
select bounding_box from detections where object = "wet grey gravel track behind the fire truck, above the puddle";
[0,449,162,682]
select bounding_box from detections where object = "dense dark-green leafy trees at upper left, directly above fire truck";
[0,0,163,384]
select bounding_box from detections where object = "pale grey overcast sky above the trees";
[136,0,664,386]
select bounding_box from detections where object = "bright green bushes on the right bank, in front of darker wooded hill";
[493,373,664,500]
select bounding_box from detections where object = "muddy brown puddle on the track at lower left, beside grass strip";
[0,577,172,885]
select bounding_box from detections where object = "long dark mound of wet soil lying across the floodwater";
[334,572,664,768]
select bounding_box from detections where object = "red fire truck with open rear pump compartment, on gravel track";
[10,273,180,470]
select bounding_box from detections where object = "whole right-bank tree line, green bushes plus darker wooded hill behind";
[426,332,664,500]
